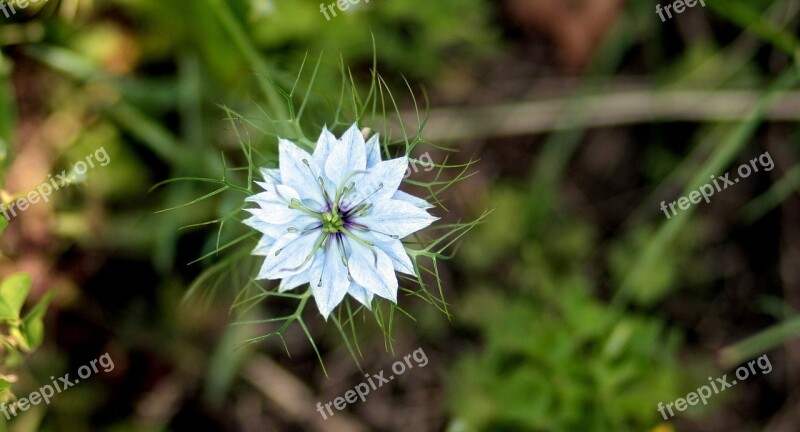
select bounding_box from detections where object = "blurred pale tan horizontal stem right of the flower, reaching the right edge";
[403,88,800,142]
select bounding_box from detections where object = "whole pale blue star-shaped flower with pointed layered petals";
[245,124,437,319]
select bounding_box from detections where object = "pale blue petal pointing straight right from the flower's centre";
[354,199,438,239]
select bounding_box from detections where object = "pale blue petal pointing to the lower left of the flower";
[256,231,322,280]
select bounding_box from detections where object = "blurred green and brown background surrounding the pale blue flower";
[0,0,800,432]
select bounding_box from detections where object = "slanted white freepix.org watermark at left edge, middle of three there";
[0,147,111,221]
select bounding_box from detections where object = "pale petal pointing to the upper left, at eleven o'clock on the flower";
[278,139,325,210]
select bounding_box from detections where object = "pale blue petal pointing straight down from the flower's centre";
[310,236,350,320]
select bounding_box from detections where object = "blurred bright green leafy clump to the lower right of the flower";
[448,191,685,431]
